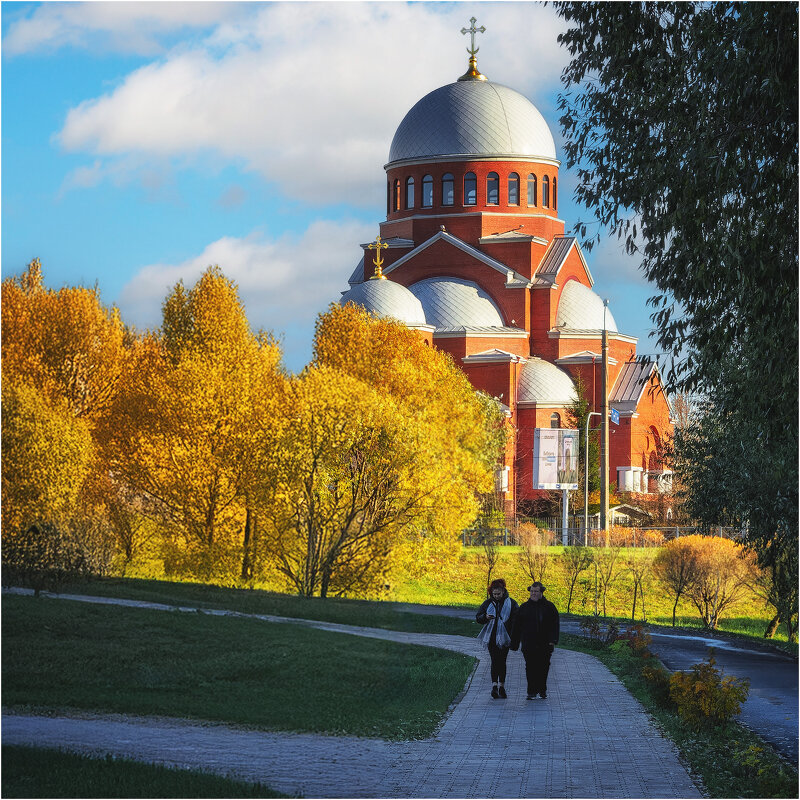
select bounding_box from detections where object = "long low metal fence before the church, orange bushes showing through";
[461,517,742,547]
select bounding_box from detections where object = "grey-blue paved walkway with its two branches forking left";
[2,598,702,798]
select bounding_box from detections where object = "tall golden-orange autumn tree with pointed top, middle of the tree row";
[101,267,283,582]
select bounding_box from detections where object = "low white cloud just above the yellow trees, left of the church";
[119,220,375,369]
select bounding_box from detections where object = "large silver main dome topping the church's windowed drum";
[389,81,556,163]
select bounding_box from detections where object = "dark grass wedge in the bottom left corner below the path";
[2,745,287,797]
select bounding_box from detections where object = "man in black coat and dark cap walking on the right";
[511,581,559,700]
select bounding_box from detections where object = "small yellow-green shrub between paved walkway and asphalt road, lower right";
[669,652,750,728]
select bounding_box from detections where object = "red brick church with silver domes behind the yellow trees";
[341,31,672,505]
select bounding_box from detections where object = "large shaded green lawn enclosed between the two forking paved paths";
[2,595,474,740]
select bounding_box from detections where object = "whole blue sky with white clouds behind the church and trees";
[2,2,656,371]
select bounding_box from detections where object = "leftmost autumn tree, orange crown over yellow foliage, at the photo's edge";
[2,259,127,588]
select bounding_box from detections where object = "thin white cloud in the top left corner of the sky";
[3,2,246,56]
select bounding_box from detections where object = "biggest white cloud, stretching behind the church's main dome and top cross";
[58,3,566,206]
